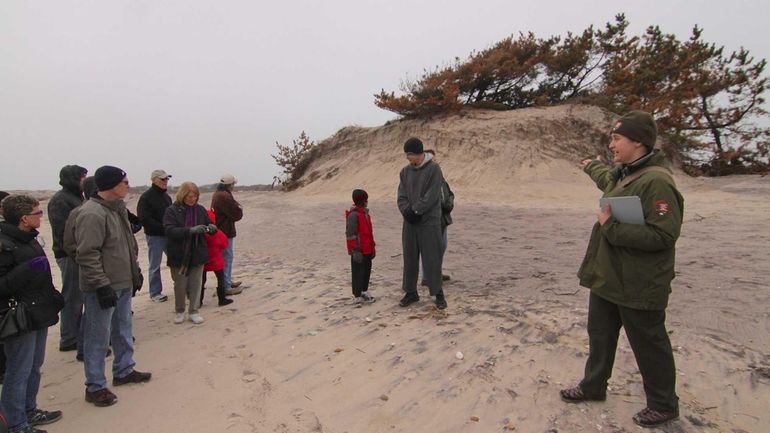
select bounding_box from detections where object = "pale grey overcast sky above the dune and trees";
[0,0,770,189]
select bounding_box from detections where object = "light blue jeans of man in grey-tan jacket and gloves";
[83,288,136,392]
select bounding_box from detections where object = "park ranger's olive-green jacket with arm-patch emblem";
[578,150,684,310]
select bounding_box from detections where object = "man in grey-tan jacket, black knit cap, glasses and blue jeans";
[75,165,151,407]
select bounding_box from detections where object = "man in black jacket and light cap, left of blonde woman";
[136,170,171,302]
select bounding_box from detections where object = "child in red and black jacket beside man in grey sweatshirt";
[345,189,375,304]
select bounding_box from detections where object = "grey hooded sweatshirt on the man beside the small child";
[398,153,444,226]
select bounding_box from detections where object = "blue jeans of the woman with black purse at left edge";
[0,328,48,428]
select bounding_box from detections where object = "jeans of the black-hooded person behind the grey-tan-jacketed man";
[56,257,83,353]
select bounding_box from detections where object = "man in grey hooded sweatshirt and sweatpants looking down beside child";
[398,137,447,309]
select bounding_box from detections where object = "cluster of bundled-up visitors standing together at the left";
[0,165,243,433]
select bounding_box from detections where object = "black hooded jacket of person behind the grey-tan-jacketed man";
[48,165,88,259]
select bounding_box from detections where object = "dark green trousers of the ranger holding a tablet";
[580,293,679,413]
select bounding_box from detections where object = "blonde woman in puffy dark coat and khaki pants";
[163,182,217,325]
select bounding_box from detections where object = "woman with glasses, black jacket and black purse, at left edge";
[0,195,64,433]
